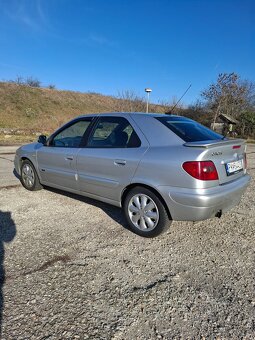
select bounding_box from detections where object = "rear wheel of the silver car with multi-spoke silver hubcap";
[123,186,170,237]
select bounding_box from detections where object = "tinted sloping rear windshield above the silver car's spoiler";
[155,116,223,142]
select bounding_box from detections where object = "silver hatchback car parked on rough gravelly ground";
[15,113,250,237]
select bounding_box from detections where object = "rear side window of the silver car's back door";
[88,117,141,148]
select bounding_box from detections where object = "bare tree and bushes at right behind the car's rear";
[166,73,255,139]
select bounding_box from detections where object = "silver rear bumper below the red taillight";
[158,175,250,221]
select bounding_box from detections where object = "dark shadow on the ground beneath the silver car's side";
[44,186,131,231]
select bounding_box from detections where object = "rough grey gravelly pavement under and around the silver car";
[0,148,255,339]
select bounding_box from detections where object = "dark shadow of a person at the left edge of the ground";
[0,210,16,338]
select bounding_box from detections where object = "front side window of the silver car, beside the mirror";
[51,119,91,148]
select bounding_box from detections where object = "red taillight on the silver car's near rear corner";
[182,161,219,181]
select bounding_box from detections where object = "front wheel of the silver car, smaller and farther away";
[20,159,43,191]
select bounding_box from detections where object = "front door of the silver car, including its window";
[37,117,92,190]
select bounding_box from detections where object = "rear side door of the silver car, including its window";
[77,116,148,201]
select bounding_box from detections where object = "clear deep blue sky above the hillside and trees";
[0,0,255,104]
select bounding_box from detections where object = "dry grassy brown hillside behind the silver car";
[0,82,164,134]
